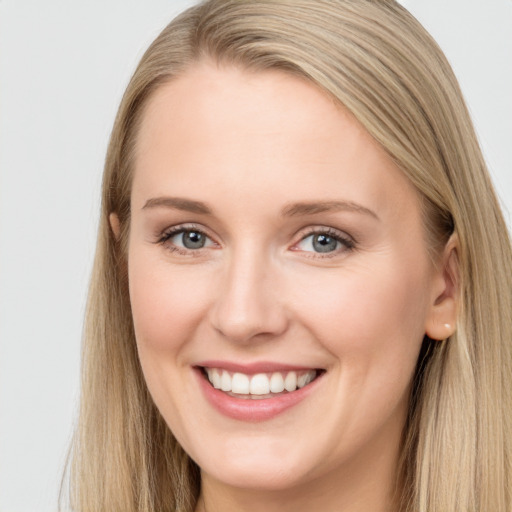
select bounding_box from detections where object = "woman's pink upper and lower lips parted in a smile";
[193,361,324,423]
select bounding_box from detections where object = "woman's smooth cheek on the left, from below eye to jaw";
[128,246,216,432]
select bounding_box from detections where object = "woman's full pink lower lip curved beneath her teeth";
[195,368,323,422]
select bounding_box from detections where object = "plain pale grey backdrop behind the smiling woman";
[0,0,512,512]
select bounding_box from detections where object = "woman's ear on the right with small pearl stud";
[425,234,459,340]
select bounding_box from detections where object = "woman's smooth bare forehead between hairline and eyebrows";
[132,63,417,222]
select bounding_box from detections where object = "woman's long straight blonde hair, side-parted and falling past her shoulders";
[65,0,512,512]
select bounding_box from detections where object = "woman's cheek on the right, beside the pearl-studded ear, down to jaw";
[288,262,428,450]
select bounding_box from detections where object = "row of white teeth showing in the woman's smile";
[206,368,316,395]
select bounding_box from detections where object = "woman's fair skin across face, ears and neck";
[111,62,455,512]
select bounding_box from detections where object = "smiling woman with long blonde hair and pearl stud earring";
[63,0,512,512]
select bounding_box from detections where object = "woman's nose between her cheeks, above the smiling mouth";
[210,248,289,343]
